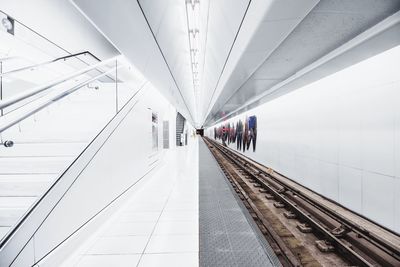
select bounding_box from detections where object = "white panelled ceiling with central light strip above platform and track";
[73,0,400,127]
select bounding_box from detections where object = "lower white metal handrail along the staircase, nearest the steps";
[0,65,124,133]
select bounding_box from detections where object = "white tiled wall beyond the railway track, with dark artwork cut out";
[208,46,400,233]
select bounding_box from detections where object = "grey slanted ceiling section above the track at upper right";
[206,0,400,125]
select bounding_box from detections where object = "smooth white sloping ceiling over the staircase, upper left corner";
[0,0,119,59]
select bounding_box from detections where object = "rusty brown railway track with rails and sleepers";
[204,138,400,266]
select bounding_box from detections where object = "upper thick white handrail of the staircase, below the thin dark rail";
[0,56,120,109]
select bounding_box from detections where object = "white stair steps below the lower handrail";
[0,77,147,241]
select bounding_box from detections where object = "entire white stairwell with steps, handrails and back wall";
[0,8,144,242]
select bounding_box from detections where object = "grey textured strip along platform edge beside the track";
[199,140,281,267]
